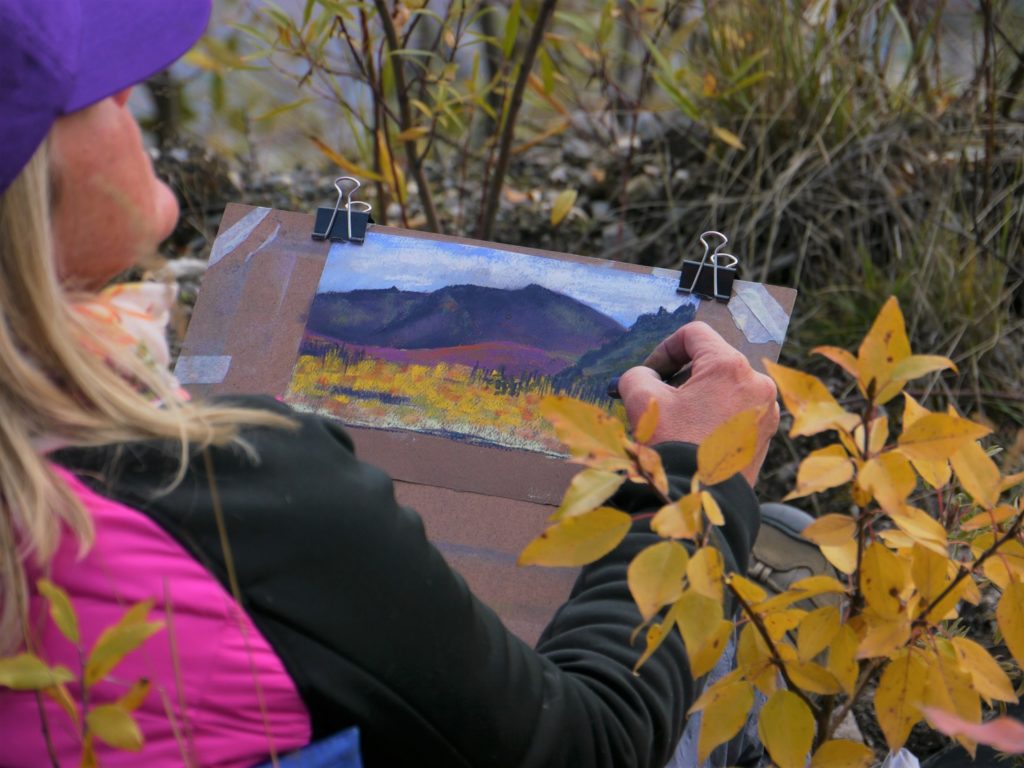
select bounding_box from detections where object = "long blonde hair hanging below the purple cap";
[0,143,290,654]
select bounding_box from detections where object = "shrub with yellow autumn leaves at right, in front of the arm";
[520,299,1024,768]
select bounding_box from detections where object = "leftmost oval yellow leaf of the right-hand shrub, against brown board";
[518,507,633,566]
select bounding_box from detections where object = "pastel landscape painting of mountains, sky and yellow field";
[286,232,698,454]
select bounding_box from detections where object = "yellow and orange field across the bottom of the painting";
[286,352,618,455]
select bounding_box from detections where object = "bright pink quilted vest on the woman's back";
[0,470,310,768]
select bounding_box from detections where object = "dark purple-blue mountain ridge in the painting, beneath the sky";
[307,285,626,355]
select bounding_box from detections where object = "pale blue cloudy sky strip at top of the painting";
[317,231,698,327]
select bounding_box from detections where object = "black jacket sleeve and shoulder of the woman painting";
[53,398,759,768]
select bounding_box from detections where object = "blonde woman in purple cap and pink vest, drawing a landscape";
[0,0,778,766]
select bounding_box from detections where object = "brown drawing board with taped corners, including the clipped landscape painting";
[175,205,796,641]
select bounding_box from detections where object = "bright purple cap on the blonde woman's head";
[0,0,211,194]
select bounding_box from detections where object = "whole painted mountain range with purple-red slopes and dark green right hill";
[302,285,695,391]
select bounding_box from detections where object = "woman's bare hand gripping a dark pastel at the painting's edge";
[618,323,778,485]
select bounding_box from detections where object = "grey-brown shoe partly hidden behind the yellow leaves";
[746,503,839,609]
